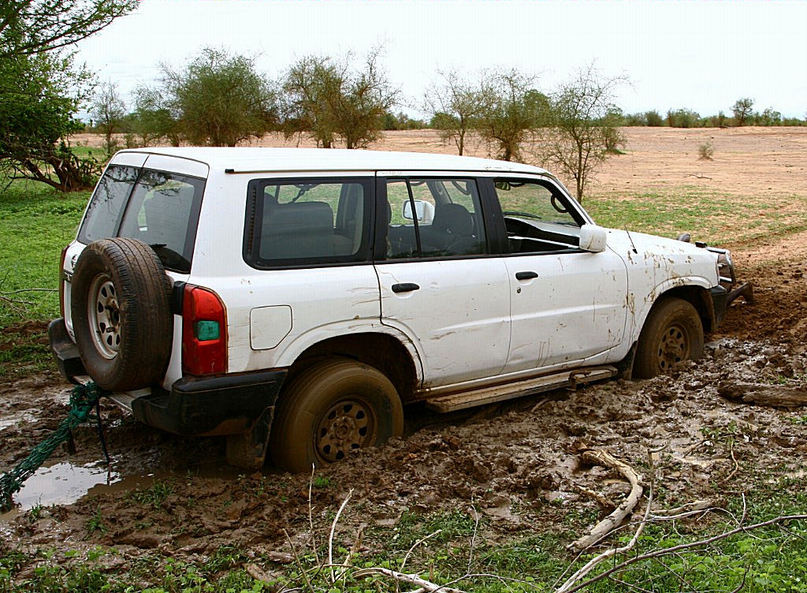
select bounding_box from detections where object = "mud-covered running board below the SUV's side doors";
[426,366,619,412]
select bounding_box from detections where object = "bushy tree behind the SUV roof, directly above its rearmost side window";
[283,50,398,148]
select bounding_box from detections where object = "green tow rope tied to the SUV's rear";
[0,382,109,511]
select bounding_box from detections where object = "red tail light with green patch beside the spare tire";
[182,284,227,376]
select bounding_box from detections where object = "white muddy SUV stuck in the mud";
[50,148,739,471]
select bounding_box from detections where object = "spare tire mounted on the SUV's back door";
[71,238,173,391]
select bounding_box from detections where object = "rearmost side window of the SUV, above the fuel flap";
[244,178,371,268]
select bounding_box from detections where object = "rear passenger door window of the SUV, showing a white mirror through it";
[385,178,487,259]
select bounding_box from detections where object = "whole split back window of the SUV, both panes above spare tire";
[78,165,204,273]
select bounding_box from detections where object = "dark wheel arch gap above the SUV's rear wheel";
[281,332,420,403]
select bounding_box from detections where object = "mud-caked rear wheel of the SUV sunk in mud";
[270,359,403,472]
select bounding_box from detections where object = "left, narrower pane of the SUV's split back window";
[78,165,138,244]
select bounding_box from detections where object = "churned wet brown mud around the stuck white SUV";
[0,130,807,584]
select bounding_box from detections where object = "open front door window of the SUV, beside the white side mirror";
[494,179,585,253]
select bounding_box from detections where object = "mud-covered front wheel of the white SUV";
[633,298,703,379]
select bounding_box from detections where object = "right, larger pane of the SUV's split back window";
[118,169,204,272]
